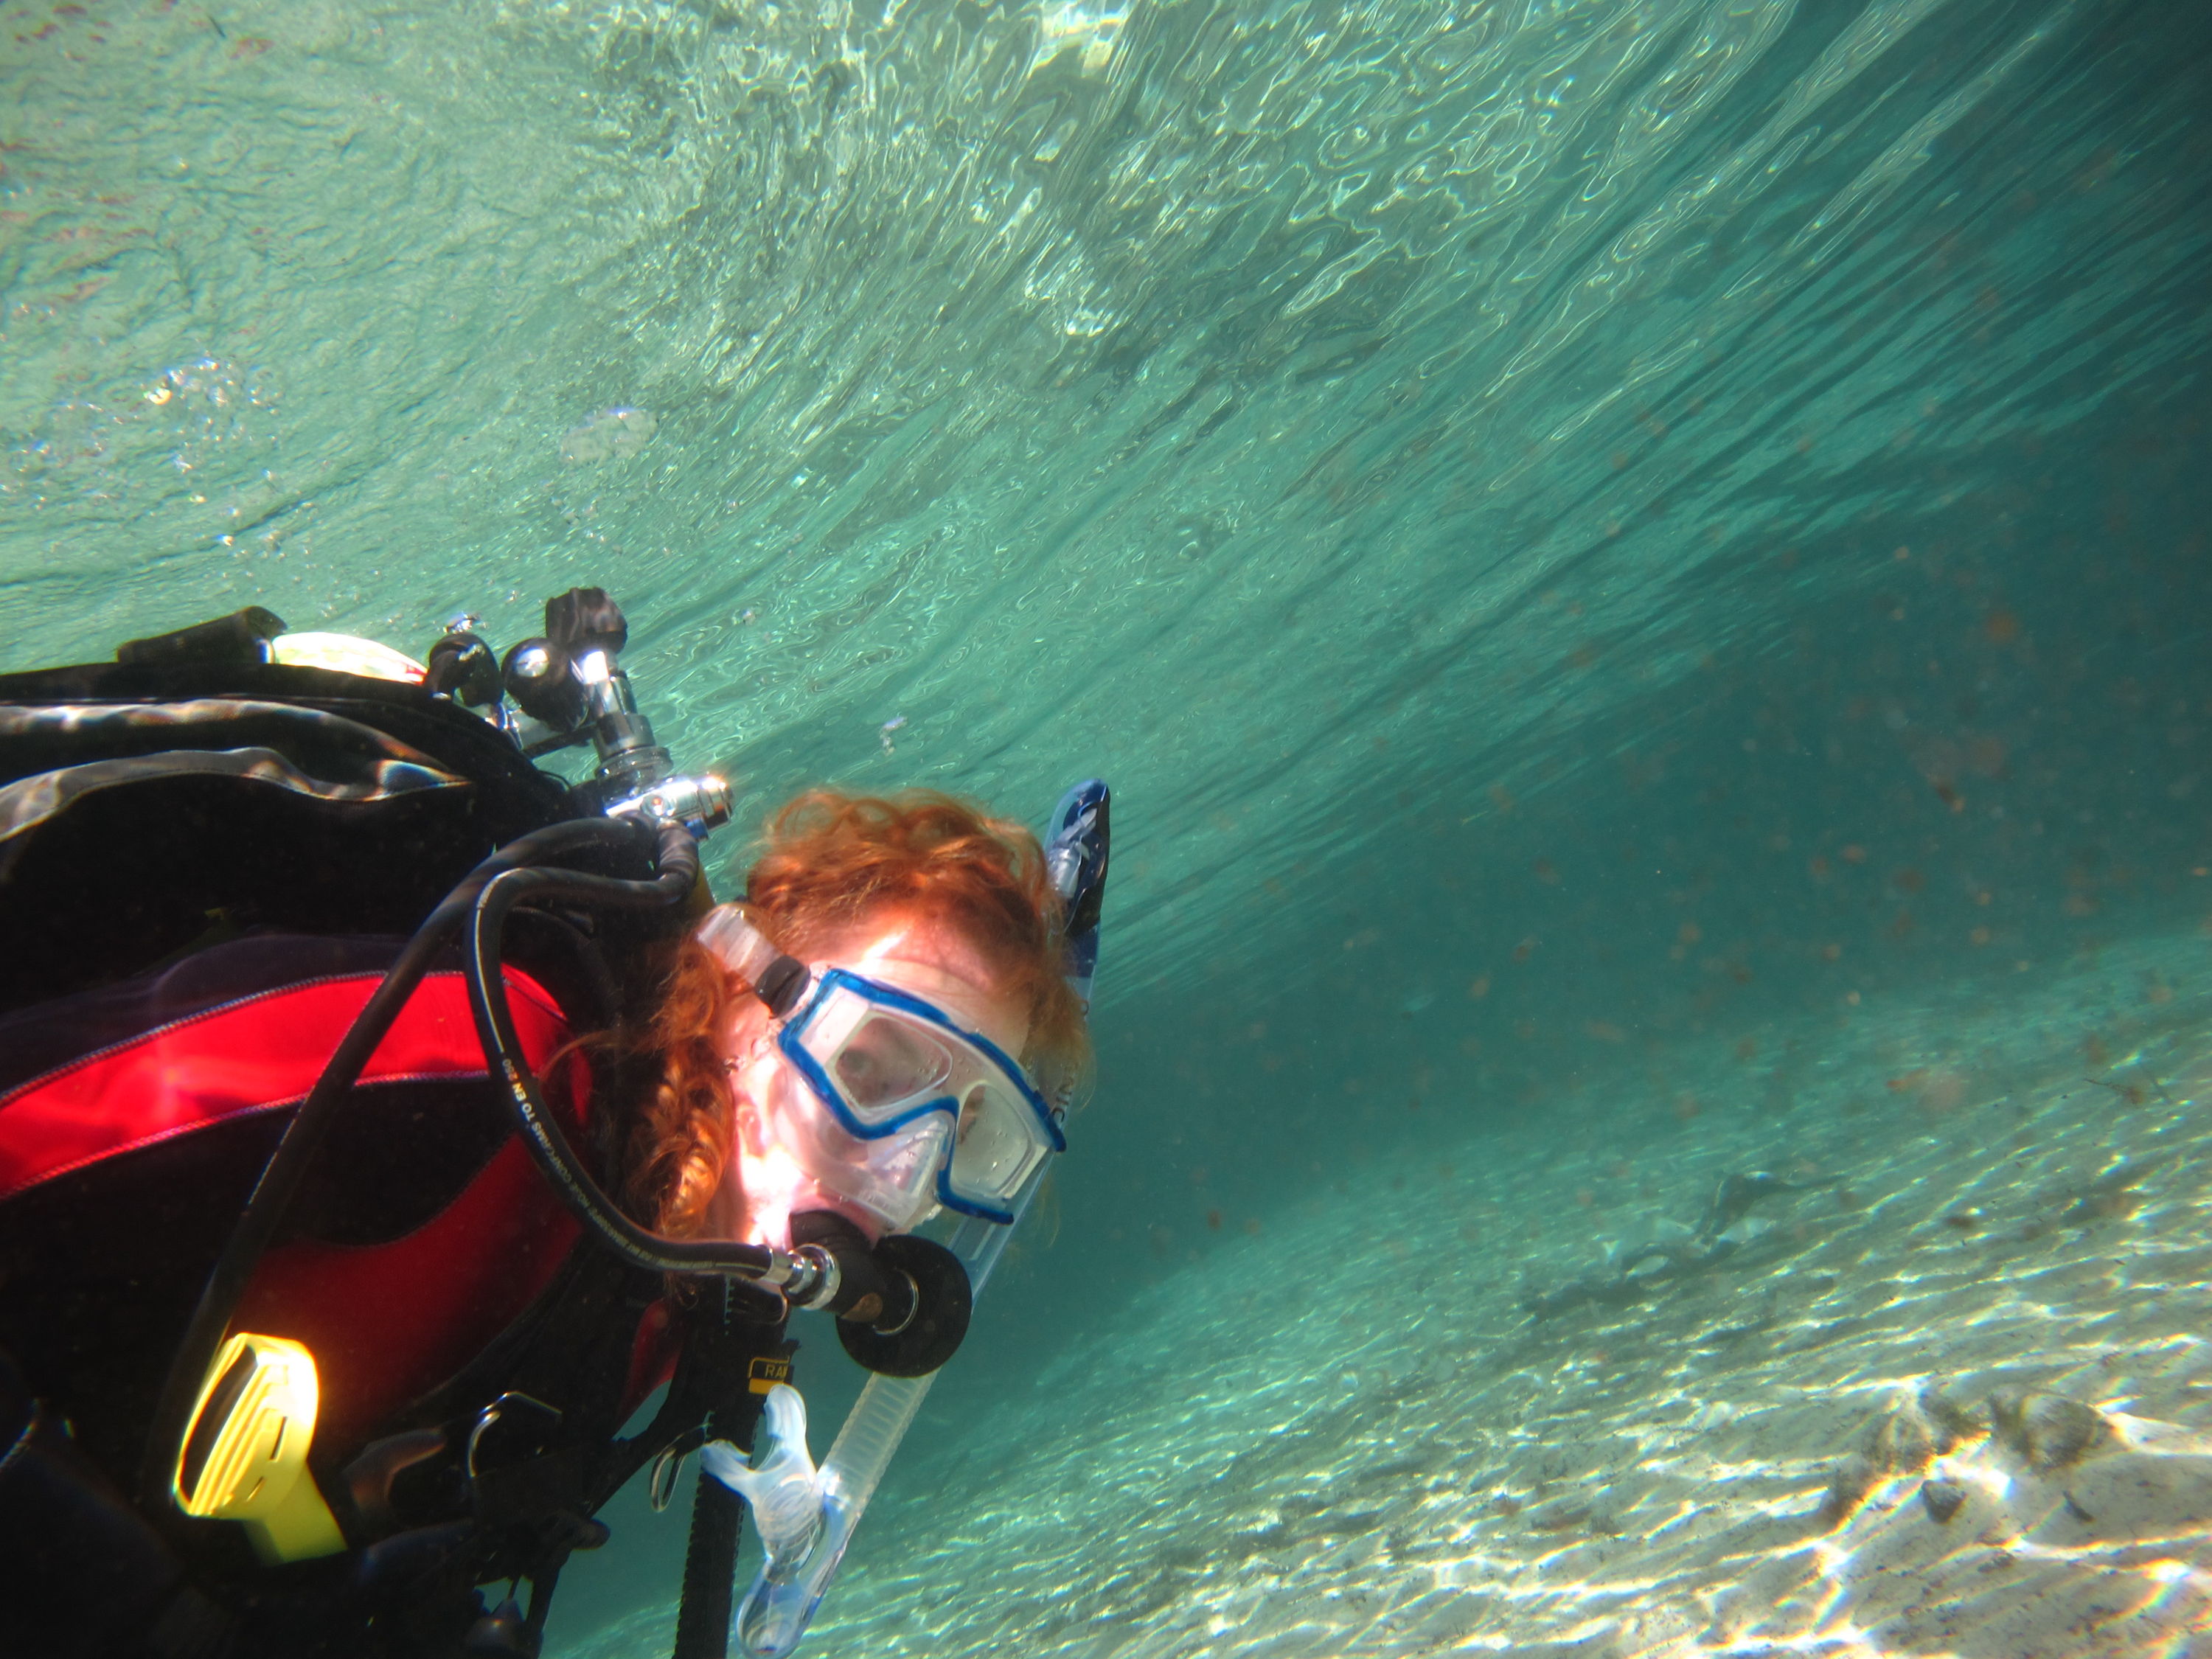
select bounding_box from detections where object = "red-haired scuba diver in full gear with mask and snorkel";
[0,588,1108,1659]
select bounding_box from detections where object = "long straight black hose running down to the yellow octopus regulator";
[139,816,646,1509]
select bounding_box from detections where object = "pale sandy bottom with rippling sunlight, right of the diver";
[575,940,2212,1659]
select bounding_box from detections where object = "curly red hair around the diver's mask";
[624,790,1091,1237]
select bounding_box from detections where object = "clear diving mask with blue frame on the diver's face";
[699,907,1066,1232]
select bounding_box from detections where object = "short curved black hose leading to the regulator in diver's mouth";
[462,825,785,1321]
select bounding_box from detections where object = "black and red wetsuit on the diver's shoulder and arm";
[0,936,681,1480]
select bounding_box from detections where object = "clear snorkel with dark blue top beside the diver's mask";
[721,779,1110,1659]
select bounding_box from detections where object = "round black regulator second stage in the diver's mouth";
[792,1210,975,1376]
